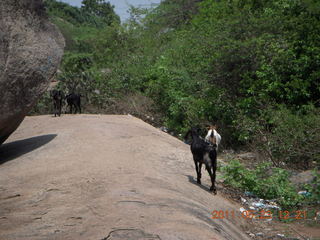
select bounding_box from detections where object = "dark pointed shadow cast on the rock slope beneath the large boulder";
[0,134,57,165]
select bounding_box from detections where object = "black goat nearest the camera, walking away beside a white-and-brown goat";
[185,128,217,194]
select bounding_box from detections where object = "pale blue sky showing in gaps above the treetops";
[60,0,161,22]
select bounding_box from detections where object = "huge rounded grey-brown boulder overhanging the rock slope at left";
[0,0,64,144]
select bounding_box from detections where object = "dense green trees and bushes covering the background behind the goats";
[35,0,320,172]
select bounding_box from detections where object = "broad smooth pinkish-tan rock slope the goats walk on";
[0,115,247,240]
